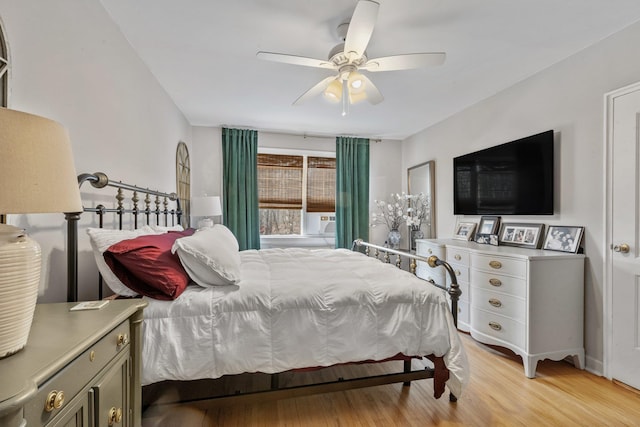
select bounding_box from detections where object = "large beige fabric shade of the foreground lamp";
[0,108,82,214]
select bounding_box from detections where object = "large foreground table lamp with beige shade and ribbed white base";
[0,108,82,358]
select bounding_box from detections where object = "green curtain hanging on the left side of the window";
[222,128,260,251]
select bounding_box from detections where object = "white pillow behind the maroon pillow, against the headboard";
[87,225,157,297]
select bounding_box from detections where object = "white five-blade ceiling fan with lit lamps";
[257,0,446,116]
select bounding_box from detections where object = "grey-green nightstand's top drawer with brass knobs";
[25,320,130,425]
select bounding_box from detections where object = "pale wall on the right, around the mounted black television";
[402,20,640,372]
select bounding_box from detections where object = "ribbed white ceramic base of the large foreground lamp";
[0,224,41,358]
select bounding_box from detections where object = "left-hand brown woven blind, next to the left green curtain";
[258,154,304,209]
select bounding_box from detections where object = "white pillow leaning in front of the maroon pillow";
[171,224,240,287]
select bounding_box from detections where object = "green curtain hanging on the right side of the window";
[336,136,369,248]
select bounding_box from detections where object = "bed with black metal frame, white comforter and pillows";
[67,173,469,412]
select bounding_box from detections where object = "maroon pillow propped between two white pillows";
[104,228,195,300]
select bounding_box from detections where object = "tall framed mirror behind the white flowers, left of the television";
[407,160,436,249]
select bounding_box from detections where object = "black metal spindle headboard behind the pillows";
[65,172,182,302]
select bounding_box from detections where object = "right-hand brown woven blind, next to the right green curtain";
[307,156,336,212]
